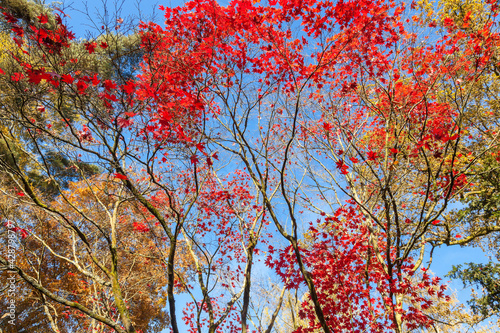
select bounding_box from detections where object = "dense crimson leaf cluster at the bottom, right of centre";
[266,207,445,332]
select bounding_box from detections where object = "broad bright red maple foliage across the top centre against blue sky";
[141,0,403,113]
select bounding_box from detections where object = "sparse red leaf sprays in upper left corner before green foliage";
[0,7,144,134]
